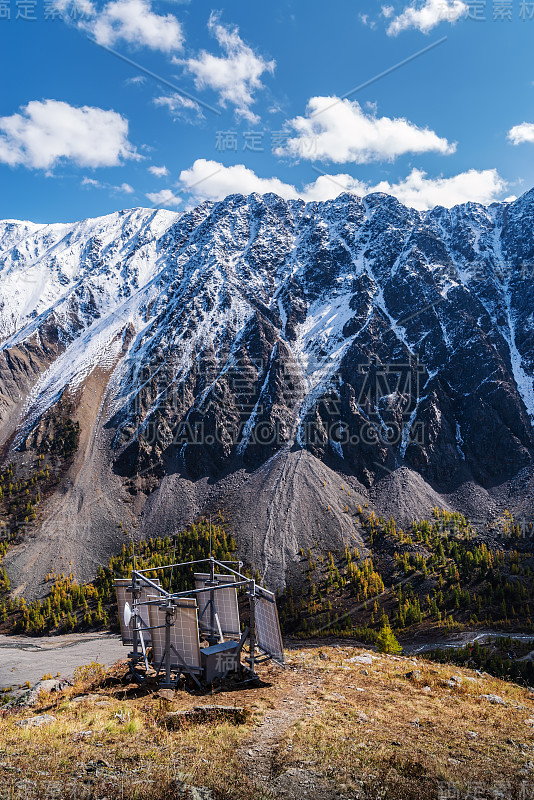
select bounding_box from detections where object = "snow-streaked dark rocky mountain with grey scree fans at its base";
[0,190,534,593]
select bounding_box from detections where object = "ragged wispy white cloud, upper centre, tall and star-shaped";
[177,13,276,123]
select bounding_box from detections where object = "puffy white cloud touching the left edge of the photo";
[0,100,140,169]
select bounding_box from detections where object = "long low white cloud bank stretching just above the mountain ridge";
[180,158,506,210]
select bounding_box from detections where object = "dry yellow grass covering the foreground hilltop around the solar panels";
[0,647,534,800]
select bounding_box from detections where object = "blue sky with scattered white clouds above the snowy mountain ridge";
[0,0,534,222]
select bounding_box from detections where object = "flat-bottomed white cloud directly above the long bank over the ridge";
[275,97,456,164]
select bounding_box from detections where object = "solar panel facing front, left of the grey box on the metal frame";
[148,595,200,669]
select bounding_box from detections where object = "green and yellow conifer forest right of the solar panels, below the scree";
[280,507,534,684]
